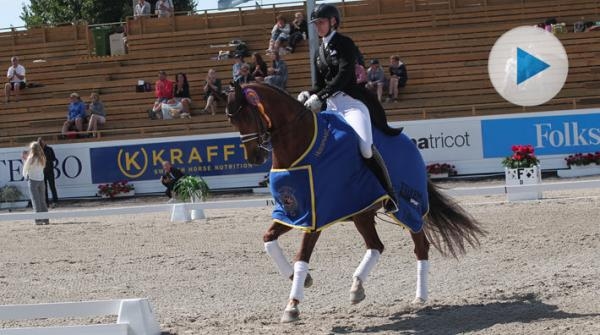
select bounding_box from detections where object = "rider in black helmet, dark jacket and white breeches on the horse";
[298,4,398,213]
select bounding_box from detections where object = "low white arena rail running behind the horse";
[0,179,600,223]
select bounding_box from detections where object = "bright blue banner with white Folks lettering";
[481,111,600,158]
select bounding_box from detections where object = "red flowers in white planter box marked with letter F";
[502,144,542,200]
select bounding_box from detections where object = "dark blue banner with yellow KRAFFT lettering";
[90,137,271,184]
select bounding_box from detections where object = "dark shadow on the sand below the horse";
[332,294,600,335]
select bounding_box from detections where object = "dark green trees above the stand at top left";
[21,0,197,27]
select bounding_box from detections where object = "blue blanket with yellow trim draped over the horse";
[269,112,429,232]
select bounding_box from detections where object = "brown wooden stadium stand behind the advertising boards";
[0,0,600,146]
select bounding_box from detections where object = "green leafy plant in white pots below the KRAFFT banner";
[171,176,209,222]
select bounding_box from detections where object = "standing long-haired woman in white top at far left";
[23,142,50,225]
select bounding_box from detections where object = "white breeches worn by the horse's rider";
[327,92,373,158]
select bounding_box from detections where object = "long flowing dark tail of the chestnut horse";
[424,180,486,258]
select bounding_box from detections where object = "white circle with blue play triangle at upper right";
[488,26,569,106]
